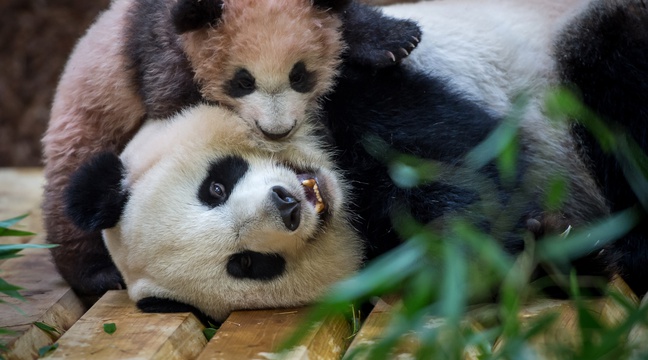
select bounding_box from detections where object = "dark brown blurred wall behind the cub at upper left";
[0,0,410,167]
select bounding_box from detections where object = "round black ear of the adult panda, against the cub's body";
[65,152,128,231]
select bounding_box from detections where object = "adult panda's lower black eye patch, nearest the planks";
[227,250,286,281]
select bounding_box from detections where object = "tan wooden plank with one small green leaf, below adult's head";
[48,290,207,360]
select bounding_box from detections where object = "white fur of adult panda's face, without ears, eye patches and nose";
[104,105,362,319]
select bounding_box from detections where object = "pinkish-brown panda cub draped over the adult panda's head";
[42,0,420,295]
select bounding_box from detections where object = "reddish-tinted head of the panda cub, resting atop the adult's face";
[172,0,351,140]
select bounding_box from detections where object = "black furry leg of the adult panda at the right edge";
[556,0,648,295]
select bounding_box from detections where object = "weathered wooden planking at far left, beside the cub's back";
[0,168,86,359]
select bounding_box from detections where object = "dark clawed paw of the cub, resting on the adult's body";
[341,1,422,69]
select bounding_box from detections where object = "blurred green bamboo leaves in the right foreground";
[284,89,648,360]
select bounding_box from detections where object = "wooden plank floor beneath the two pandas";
[0,168,648,359]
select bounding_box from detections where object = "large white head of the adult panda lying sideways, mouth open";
[67,105,362,319]
